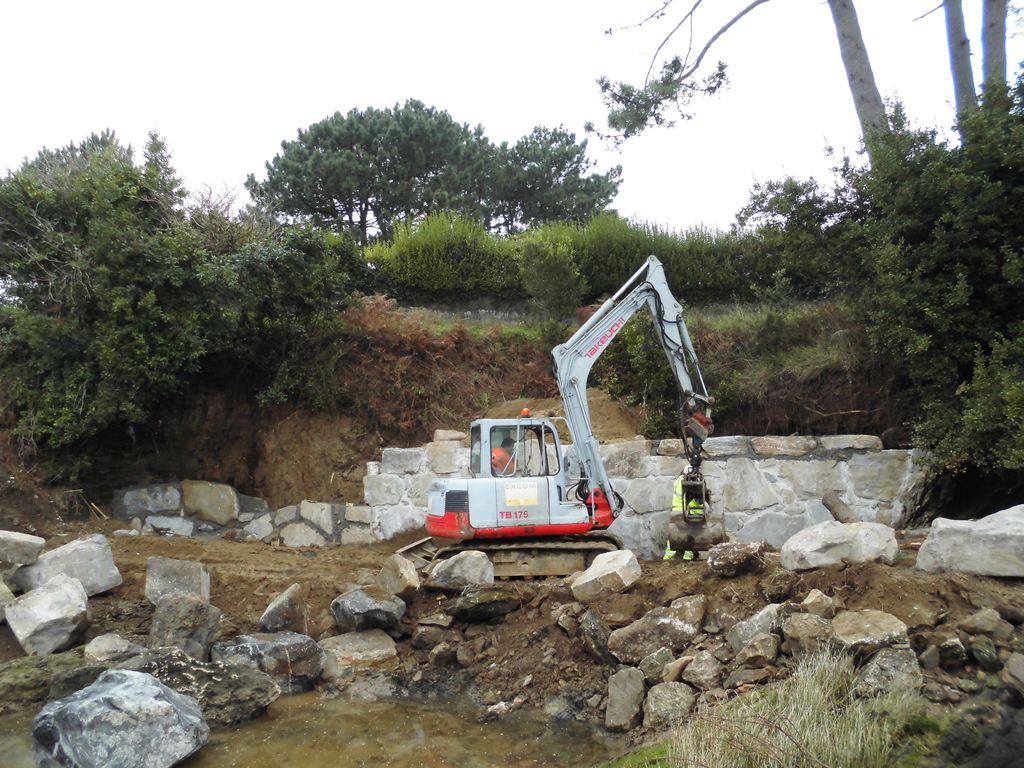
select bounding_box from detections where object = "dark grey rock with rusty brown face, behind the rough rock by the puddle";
[210,632,326,693]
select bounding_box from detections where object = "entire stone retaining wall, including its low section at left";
[113,430,925,558]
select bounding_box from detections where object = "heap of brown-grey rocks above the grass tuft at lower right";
[553,561,1024,731]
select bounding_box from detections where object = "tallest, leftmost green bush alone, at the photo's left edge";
[0,134,219,456]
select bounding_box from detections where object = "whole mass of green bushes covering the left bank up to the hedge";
[0,134,357,471]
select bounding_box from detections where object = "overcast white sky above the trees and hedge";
[0,0,1024,229]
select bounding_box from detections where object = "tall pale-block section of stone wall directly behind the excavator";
[364,432,925,558]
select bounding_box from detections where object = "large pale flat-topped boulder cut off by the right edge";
[918,504,1024,578]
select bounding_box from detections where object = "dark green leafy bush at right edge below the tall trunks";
[858,81,1024,469]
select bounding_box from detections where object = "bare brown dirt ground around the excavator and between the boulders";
[0,512,1024,720]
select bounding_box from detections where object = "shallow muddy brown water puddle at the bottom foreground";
[0,693,622,768]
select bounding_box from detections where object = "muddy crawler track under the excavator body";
[399,531,623,579]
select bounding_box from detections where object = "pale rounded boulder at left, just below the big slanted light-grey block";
[6,574,89,655]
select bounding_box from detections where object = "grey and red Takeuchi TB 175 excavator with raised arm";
[415,256,724,578]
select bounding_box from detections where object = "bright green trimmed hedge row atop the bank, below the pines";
[367,213,777,303]
